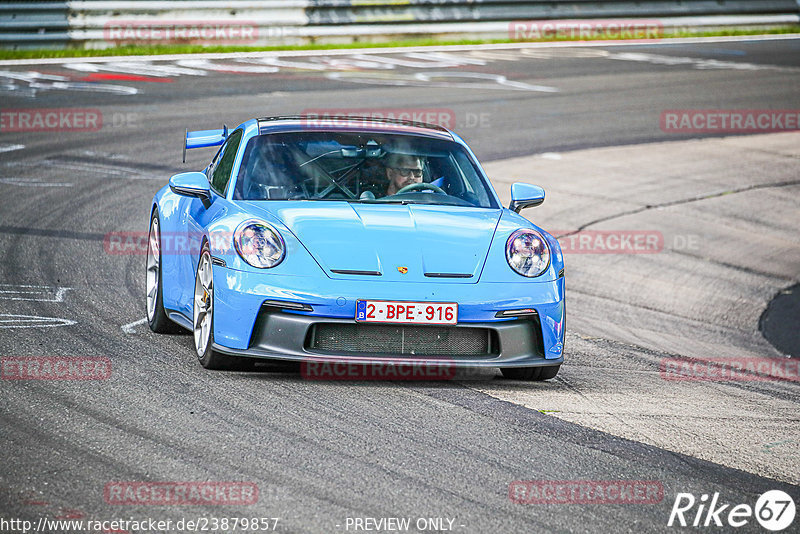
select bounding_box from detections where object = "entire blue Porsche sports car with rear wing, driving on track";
[146,117,565,380]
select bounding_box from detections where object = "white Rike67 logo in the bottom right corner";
[667,490,795,532]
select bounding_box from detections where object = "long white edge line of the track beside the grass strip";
[0,33,800,66]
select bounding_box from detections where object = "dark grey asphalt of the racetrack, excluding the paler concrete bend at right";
[0,39,800,532]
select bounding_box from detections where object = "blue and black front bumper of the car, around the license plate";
[213,266,564,367]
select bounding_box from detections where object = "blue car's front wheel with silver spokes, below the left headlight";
[192,243,247,370]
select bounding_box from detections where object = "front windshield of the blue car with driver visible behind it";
[234,132,497,208]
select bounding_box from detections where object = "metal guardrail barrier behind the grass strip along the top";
[0,0,800,48]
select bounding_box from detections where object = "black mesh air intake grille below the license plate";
[306,323,499,356]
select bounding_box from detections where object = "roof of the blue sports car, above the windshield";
[256,114,454,141]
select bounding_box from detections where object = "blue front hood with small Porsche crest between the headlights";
[249,202,502,283]
